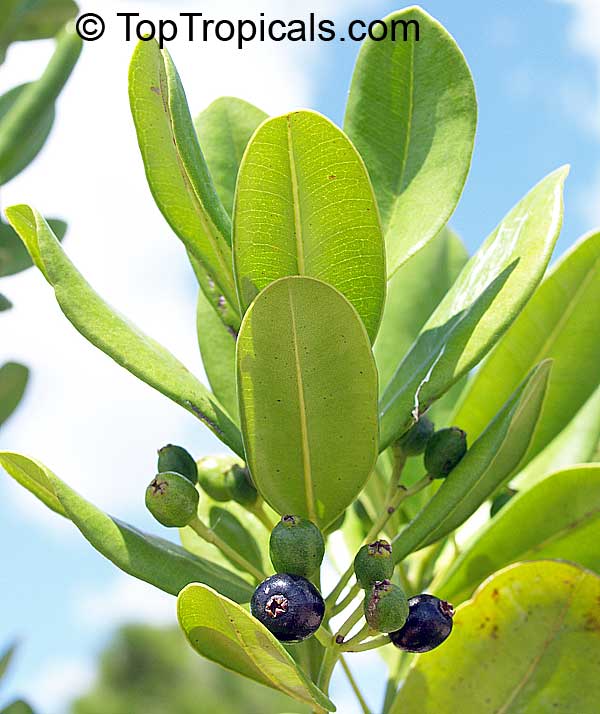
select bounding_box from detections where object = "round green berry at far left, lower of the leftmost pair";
[146,472,199,528]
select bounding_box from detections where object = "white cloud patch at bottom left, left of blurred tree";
[28,659,96,714]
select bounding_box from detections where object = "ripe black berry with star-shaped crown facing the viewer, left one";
[250,573,325,642]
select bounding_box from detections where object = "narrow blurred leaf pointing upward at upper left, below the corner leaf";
[0,26,82,185]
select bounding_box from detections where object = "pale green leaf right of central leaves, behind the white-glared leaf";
[373,228,469,390]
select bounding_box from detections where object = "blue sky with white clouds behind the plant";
[0,0,600,714]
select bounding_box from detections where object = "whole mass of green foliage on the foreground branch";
[0,8,600,714]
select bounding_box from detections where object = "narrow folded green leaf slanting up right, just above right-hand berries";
[394,361,551,562]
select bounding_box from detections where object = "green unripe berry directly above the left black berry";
[269,516,325,578]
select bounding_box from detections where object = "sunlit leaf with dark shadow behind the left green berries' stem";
[179,491,270,584]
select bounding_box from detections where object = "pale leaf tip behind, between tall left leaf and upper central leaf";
[195,97,267,216]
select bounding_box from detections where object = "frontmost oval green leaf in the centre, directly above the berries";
[237,277,377,528]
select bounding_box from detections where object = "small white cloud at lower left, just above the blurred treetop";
[73,573,176,632]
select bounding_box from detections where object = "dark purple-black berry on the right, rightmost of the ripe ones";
[390,594,454,652]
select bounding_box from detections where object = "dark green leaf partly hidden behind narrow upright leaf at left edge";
[0,82,55,184]
